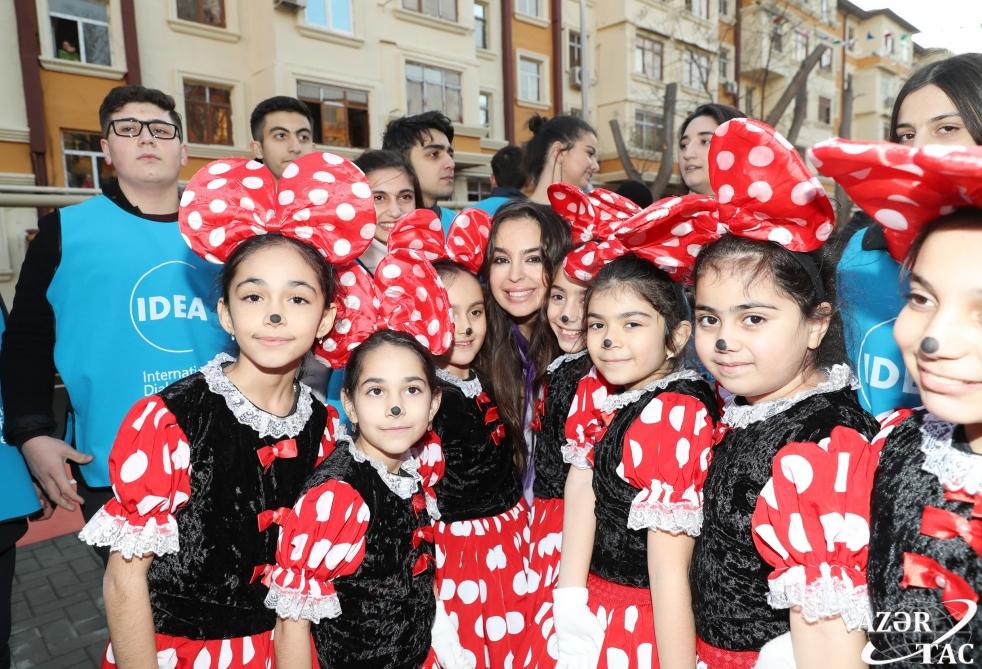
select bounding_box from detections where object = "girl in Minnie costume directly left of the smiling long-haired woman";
[390,209,528,669]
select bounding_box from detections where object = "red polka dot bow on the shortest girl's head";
[314,210,454,367]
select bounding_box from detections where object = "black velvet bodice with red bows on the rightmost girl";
[867,410,982,667]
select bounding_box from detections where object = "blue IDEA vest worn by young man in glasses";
[48,195,229,487]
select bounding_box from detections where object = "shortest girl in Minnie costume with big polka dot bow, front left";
[266,211,473,669]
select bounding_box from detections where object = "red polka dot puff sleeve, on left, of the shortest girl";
[266,480,371,623]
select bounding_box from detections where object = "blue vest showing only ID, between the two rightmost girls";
[836,229,921,416]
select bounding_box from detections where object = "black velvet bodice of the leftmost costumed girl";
[147,372,327,639]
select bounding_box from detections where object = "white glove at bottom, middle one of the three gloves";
[552,588,604,669]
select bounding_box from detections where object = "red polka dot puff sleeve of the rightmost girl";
[752,426,908,630]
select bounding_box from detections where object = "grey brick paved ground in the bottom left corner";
[10,534,108,669]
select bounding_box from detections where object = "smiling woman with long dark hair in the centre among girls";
[475,201,572,499]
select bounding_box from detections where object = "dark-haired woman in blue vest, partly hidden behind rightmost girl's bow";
[836,53,982,415]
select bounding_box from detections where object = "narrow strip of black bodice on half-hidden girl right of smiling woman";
[532,355,593,499]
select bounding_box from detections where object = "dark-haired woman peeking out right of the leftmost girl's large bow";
[354,151,423,272]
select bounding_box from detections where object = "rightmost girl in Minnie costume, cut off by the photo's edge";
[754,139,982,667]
